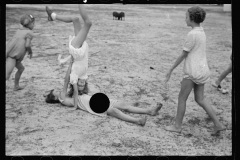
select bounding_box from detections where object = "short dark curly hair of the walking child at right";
[188,6,206,23]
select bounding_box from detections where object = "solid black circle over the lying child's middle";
[89,93,110,113]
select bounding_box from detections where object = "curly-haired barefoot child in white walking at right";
[165,6,225,134]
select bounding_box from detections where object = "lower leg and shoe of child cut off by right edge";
[212,55,232,94]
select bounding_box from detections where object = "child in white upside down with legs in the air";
[46,4,92,108]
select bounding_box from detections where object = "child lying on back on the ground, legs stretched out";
[44,57,162,126]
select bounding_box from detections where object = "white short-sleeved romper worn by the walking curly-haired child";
[183,27,210,84]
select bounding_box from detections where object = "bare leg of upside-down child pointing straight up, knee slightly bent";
[71,4,92,48]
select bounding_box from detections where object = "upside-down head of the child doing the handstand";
[68,78,88,97]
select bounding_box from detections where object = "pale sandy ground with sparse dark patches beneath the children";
[5,4,232,156]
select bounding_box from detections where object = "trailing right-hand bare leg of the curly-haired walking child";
[194,84,225,133]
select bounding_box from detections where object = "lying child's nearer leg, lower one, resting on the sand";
[107,108,147,126]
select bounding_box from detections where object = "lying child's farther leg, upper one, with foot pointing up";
[114,102,162,116]
